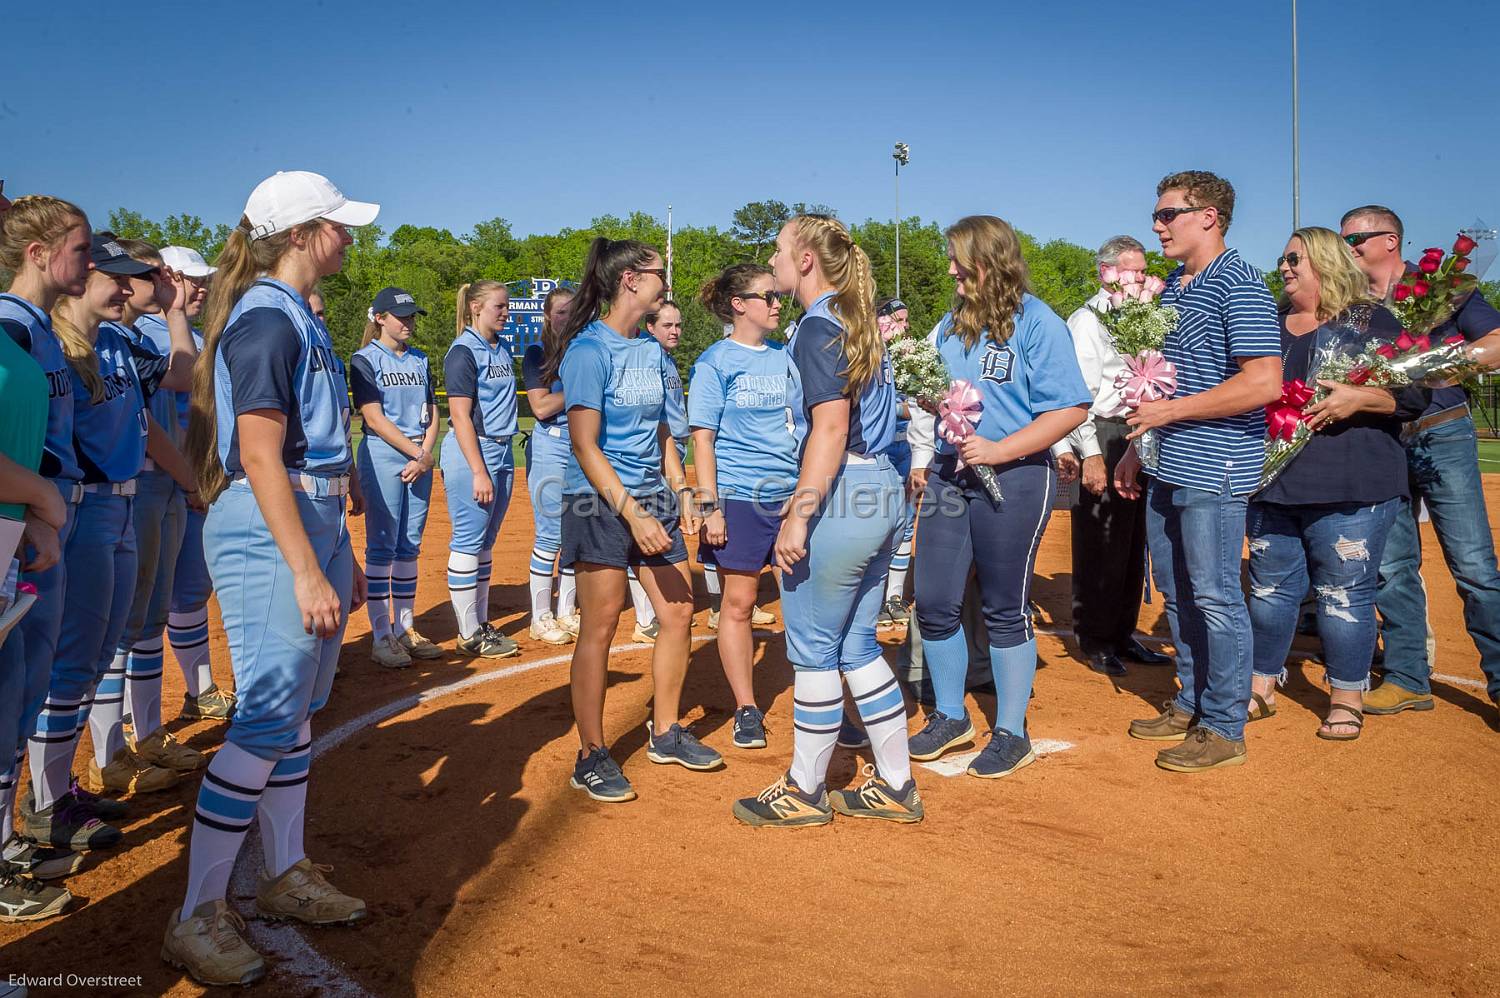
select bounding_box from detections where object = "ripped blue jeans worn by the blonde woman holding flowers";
[1250,498,1403,690]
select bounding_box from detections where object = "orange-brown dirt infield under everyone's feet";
[0,476,1500,998]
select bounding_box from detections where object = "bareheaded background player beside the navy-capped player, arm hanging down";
[441,281,521,659]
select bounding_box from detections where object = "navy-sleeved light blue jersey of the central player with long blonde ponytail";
[791,291,897,456]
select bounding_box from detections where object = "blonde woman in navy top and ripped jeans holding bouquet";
[1250,228,1431,741]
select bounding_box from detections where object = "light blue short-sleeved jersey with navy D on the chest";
[933,294,1094,453]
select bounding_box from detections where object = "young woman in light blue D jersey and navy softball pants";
[912,215,1092,779]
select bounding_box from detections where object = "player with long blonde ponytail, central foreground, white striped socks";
[734,215,923,825]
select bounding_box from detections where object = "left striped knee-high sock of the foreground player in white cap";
[182,741,276,918]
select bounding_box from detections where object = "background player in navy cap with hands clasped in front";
[350,288,443,669]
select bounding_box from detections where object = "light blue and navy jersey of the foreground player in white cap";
[213,278,353,476]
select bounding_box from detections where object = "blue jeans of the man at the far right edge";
[1376,417,1500,702]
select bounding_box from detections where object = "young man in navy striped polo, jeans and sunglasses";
[1115,170,1281,773]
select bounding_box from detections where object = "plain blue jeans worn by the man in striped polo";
[1146,479,1253,741]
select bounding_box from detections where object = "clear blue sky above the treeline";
[0,0,1500,276]
